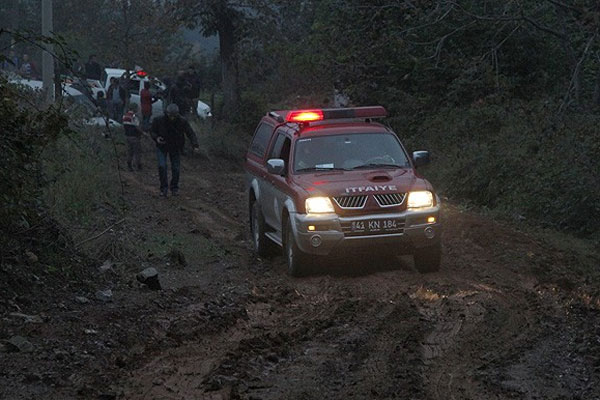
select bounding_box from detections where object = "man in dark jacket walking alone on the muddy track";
[151,104,198,197]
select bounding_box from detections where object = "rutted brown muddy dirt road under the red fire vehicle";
[0,152,600,400]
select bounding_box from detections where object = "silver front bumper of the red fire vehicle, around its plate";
[291,206,441,256]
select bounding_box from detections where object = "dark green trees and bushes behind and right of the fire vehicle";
[229,0,600,238]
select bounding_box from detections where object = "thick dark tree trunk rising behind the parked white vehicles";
[219,15,240,119]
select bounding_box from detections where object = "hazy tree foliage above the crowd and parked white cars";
[0,0,190,74]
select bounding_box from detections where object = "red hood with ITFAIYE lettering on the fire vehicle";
[294,169,430,196]
